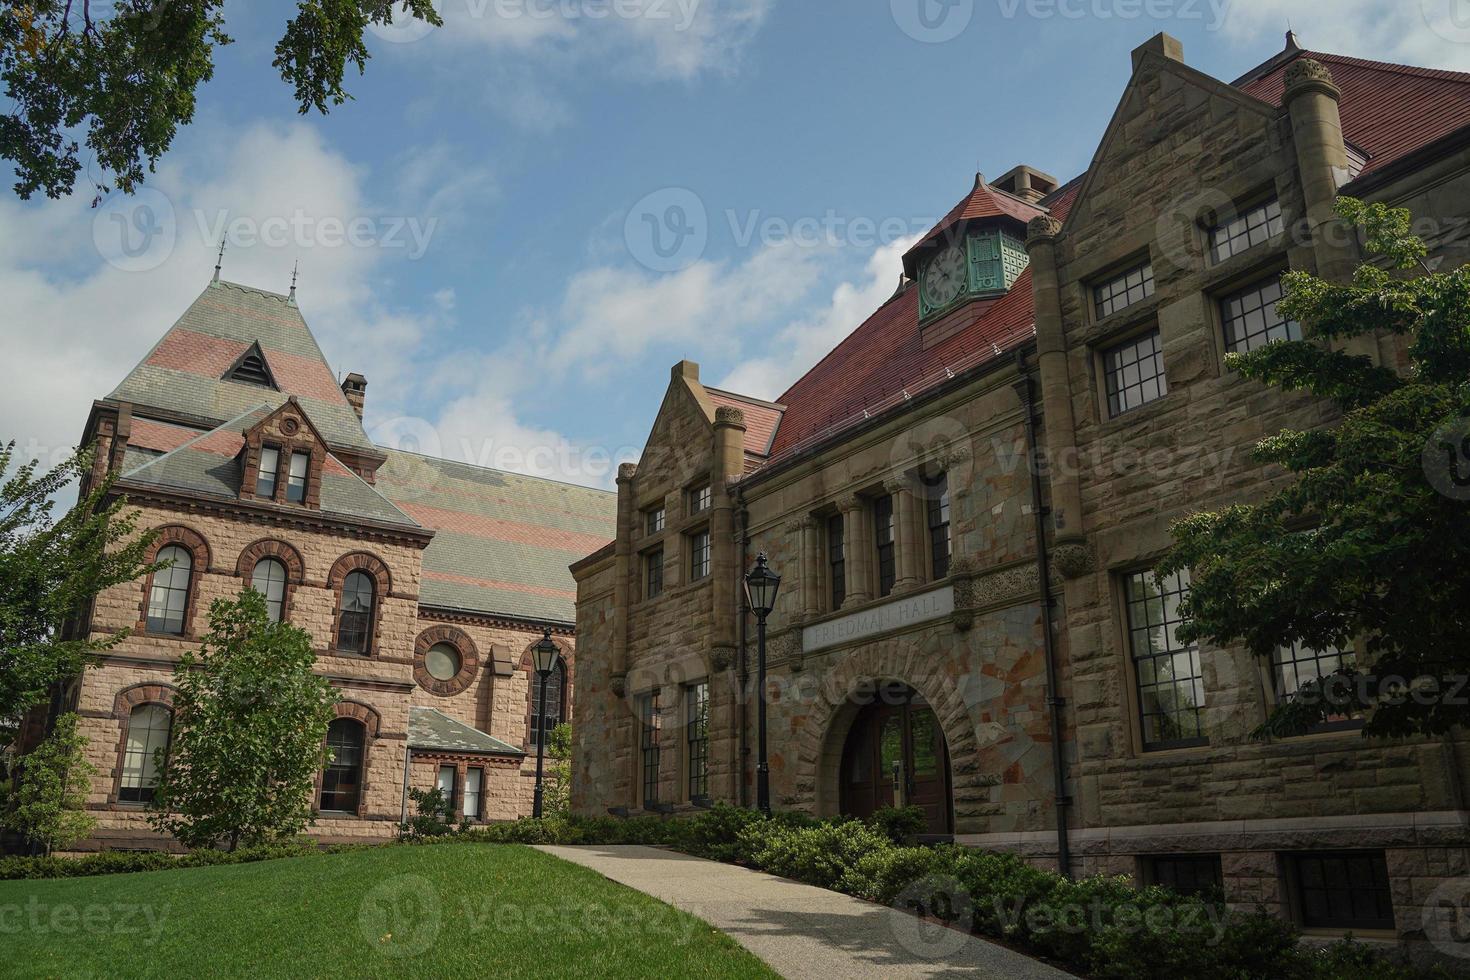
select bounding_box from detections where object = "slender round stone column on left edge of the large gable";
[1026,216,1082,542]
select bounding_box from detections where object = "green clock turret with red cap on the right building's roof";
[904,173,1047,323]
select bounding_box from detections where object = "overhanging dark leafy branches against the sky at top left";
[0,0,441,198]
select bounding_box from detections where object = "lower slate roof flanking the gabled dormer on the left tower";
[121,406,419,529]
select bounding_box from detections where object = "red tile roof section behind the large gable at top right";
[1236,51,1470,173]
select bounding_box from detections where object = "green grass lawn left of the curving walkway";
[0,843,775,977]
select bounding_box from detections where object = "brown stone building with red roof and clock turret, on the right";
[573,35,1470,939]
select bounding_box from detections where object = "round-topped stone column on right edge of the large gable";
[1282,57,1379,364]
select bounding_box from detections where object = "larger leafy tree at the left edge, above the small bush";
[0,442,154,727]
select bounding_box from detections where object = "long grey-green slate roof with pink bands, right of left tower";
[376,450,617,623]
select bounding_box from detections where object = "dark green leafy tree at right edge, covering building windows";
[1160,198,1470,736]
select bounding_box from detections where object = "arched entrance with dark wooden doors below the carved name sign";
[838,682,954,835]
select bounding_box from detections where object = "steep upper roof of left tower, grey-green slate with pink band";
[107,282,372,450]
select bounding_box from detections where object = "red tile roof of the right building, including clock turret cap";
[747,41,1470,472]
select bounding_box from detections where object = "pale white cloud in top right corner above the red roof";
[1222,0,1470,71]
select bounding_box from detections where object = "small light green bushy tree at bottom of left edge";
[6,713,97,854]
